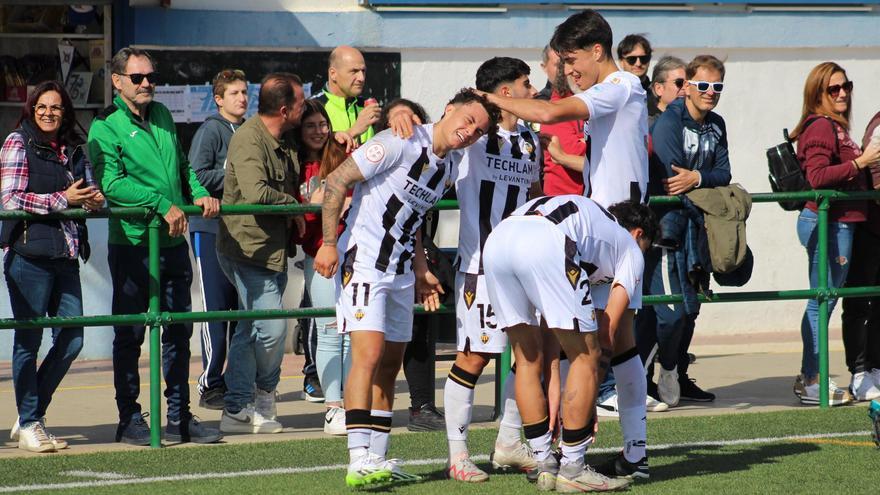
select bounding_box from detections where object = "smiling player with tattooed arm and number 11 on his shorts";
[315,90,499,487]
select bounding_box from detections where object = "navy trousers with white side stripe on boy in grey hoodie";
[190,232,238,393]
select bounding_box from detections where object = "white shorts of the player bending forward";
[482,216,598,332]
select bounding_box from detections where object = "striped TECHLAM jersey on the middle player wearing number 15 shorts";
[455,124,542,273]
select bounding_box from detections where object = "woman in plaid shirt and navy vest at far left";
[0,81,104,452]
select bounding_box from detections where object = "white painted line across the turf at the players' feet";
[0,430,872,493]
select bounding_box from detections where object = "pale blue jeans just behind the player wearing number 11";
[303,256,351,403]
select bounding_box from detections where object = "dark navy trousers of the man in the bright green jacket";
[107,242,192,424]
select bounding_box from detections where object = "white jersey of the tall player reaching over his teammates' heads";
[574,71,648,207]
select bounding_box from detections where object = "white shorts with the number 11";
[336,255,415,342]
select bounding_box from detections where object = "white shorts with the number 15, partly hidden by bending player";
[455,272,507,354]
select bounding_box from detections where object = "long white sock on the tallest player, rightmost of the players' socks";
[612,348,648,462]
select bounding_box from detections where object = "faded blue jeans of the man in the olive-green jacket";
[217,253,287,413]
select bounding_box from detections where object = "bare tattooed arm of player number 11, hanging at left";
[315,157,364,278]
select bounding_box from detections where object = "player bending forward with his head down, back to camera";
[482,195,658,492]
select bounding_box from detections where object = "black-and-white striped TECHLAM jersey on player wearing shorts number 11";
[339,124,462,274]
